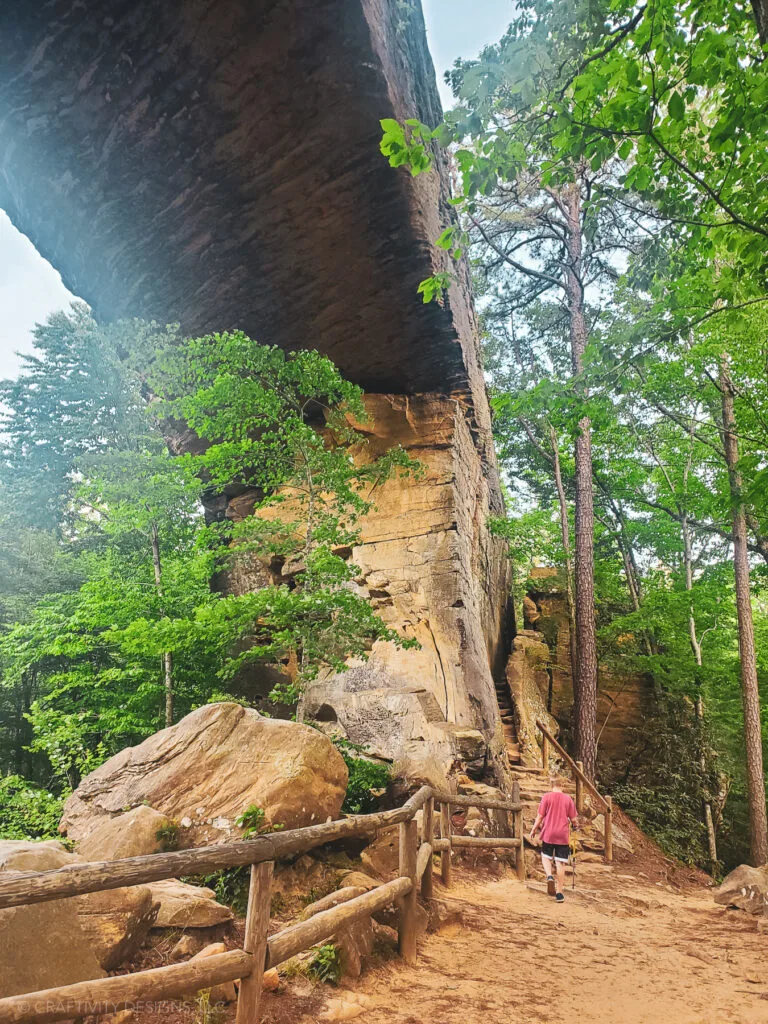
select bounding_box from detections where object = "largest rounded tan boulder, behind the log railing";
[59,703,347,849]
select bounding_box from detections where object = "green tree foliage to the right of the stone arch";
[382,0,768,864]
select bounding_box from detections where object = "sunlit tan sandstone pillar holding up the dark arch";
[306,395,508,784]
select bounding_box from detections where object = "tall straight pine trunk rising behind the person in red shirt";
[562,183,597,779]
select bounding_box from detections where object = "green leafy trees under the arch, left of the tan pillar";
[0,315,420,788]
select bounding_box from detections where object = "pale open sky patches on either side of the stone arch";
[0,0,514,378]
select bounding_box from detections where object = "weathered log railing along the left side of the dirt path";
[0,782,525,1024]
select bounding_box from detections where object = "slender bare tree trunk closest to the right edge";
[720,356,768,866]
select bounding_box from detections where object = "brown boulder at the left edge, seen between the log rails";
[0,841,158,995]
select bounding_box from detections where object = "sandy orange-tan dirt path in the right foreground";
[317,867,768,1024]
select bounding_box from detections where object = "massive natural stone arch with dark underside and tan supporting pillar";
[0,0,508,780]
